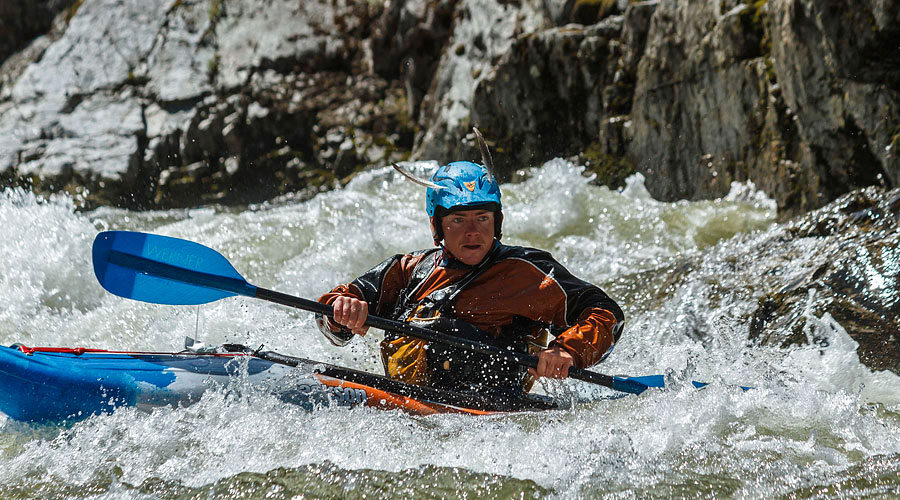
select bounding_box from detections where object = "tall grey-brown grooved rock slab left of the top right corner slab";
[629,2,781,205]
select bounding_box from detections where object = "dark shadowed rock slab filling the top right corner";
[769,0,900,209]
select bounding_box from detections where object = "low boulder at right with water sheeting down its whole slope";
[617,187,900,373]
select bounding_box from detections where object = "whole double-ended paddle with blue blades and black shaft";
[93,231,724,394]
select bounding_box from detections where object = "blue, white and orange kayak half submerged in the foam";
[0,344,556,423]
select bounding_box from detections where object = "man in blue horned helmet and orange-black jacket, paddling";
[318,129,624,393]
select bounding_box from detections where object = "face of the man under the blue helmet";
[441,210,494,266]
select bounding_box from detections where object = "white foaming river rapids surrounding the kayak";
[0,160,900,499]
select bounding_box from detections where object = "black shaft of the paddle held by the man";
[255,287,632,394]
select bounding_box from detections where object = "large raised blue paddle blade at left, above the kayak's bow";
[93,231,256,305]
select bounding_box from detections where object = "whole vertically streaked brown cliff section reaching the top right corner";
[630,0,900,217]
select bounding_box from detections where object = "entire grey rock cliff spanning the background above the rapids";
[0,0,900,216]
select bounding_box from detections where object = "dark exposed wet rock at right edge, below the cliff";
[749,188,900,373]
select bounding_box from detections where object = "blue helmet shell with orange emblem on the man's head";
[425,161,503,243]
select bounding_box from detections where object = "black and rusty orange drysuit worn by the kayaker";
[319,243,624,392]
